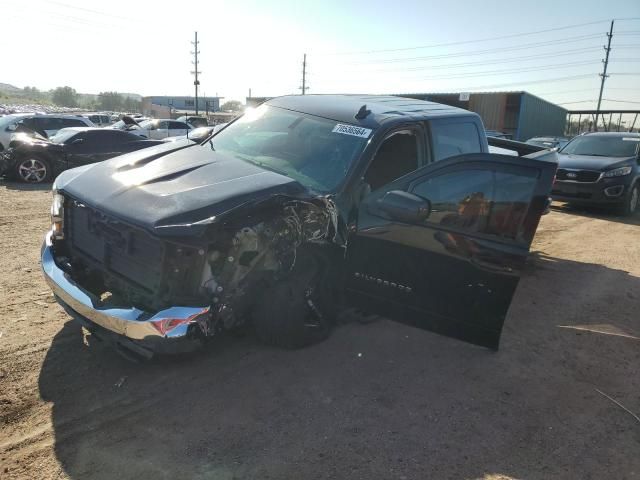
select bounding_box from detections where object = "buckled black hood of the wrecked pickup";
[55,142,307,235]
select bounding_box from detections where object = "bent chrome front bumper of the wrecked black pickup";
[41,232,210,357]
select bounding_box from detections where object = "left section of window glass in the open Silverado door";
[412,170,494,232]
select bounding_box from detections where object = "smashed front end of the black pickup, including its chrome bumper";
[42,191,342,357]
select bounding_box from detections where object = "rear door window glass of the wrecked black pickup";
[431,122,482,161]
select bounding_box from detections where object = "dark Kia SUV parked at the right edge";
[553,132,640,215]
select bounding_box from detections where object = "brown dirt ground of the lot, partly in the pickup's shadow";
[0,183,640,480]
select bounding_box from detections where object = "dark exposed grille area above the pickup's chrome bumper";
[65,200,164,293]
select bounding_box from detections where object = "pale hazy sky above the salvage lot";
[0,0,640,109]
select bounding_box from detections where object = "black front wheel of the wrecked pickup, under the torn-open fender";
[252,251,335,349]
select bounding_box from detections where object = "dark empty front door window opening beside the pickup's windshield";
[364,130,419,191]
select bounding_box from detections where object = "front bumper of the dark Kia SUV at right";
[551,177,631,205]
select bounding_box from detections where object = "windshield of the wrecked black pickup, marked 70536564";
[209,105,370,192]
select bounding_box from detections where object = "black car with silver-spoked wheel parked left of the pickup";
[0,127,162,183]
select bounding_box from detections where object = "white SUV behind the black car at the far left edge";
[0,113,95,151]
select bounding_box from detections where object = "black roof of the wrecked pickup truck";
[266,95,476,128]
